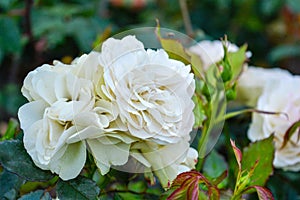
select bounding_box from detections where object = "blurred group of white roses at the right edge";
[237,67,300,171]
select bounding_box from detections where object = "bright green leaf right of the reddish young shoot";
[242,136,274,186]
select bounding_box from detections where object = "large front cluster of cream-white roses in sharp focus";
[18,36,198,186]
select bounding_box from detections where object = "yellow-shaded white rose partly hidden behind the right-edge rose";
[236,67,291,107]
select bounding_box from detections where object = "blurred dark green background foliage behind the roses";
[0,0,300,199]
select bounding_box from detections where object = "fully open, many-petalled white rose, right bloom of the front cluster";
[100,36,195,144]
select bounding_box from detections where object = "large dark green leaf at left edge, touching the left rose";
[0,140,53,181]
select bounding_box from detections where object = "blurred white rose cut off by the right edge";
[248,74,300,171]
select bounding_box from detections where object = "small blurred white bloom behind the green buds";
[189,40,251,70]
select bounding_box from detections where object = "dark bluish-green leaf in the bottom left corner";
[0,170,25,199]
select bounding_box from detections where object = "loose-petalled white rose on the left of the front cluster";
[18,58,94,180]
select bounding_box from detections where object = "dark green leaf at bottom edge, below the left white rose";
[56,176,100,200]
